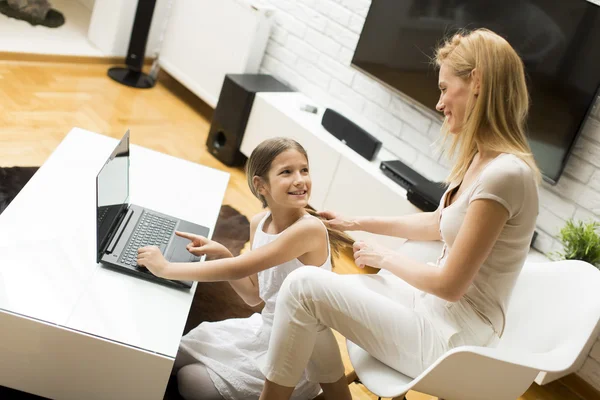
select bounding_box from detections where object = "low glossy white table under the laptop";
[0,128,229,400]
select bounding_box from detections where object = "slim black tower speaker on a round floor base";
[108,0,156,89]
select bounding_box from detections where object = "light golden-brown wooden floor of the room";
[0,57,580,400]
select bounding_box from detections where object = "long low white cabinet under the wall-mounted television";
[240,93,421,248]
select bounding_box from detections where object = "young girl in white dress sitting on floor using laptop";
[138,138,352,400]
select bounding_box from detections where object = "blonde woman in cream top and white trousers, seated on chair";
[261,29,540,400]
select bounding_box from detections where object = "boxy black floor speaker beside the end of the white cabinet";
[206,74,293,166]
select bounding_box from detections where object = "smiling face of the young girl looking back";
[263,149,312,208]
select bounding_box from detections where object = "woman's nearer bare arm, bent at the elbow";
[355,199,508,302]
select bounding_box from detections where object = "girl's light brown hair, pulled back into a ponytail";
[246,137,354,264]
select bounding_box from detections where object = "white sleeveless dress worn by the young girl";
[179,212,331,400]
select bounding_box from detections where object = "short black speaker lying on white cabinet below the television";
[321,108,381,161]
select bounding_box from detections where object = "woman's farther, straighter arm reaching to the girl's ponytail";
[319,209,441,240]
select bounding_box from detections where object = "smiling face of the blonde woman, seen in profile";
[435,63,473,134]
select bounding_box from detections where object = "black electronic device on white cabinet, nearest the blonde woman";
[379,160,447,211]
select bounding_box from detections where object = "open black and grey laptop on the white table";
[96,130,209,288]
